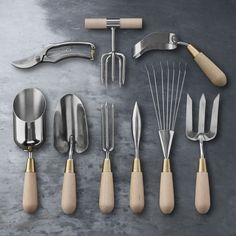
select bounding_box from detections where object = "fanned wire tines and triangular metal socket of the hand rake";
[146,62,186,158]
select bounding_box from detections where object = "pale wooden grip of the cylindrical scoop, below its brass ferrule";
[23,172,38,213]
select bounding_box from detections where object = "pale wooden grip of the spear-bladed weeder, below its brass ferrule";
[129,171,144,213]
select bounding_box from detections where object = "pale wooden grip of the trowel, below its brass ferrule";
[61,173,76,214]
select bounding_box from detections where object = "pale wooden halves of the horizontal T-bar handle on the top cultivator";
[85,18,143,29]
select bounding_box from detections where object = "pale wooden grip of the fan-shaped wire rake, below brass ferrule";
[159,172,175,214]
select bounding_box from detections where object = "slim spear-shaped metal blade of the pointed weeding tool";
[132,102,142,158]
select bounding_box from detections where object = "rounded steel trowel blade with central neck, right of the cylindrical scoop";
[54,94,89,156]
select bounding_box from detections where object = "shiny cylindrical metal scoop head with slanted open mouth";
[13,88,46,152]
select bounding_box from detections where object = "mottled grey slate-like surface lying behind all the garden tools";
[0,0,236,236]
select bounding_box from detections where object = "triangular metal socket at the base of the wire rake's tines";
[159,130,174,158]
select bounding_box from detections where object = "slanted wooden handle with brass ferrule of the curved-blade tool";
[187,44,227,87]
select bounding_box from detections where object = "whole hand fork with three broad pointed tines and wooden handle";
[186,94,220,214]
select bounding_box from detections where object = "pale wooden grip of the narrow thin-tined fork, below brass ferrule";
[99,171,115,214]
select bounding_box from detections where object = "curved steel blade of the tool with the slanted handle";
[133,32,179,58]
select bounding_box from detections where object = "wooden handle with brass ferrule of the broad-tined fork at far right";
[195,158,211,214]
